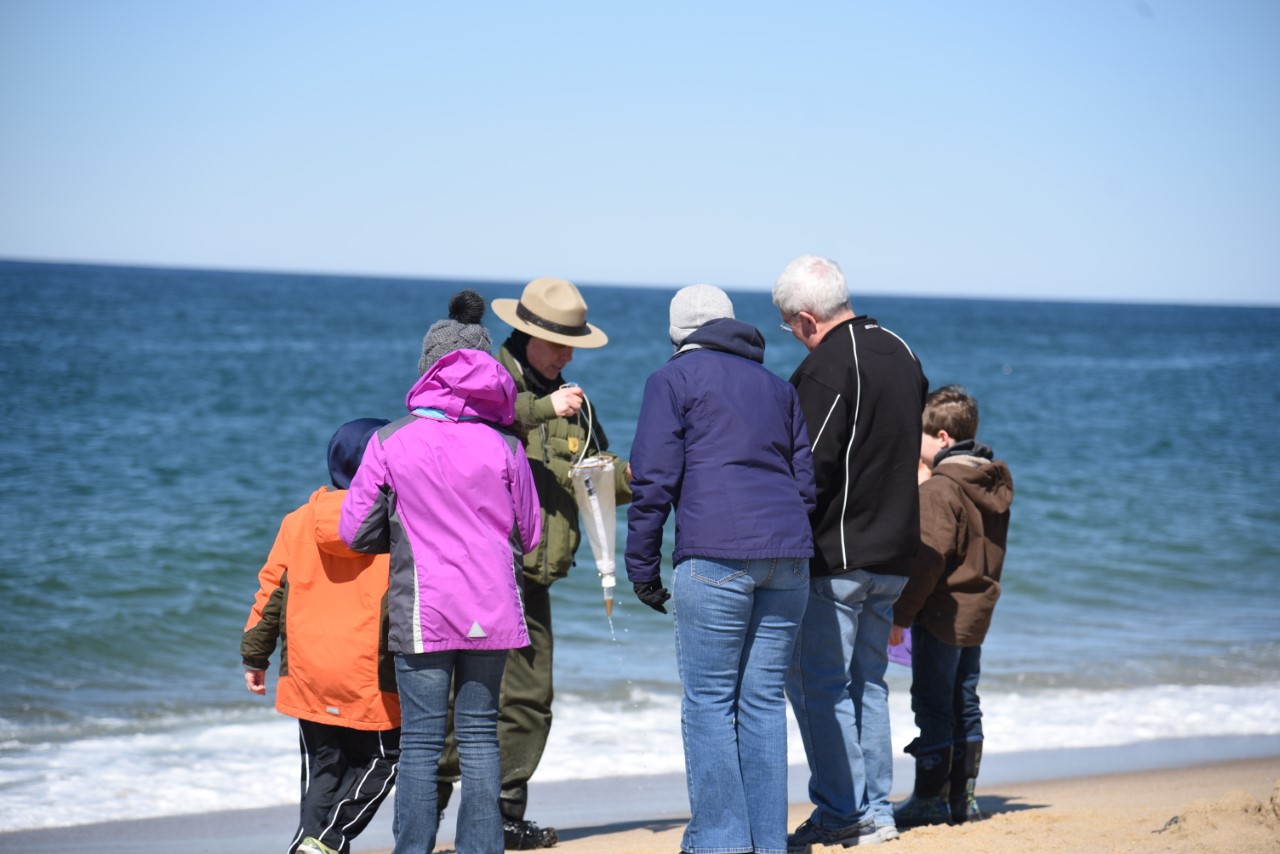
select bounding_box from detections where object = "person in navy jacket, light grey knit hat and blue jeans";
[626,284,814,854]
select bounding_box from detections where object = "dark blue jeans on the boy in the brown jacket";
[911,625,982,750]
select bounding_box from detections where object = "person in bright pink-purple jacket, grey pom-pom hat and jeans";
[339,294,541,854]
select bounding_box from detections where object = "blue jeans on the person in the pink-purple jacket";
[393,649,507,854]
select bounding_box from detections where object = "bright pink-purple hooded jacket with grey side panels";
[338,350,541,653]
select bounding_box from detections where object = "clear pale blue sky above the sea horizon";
[0,0,1280,305]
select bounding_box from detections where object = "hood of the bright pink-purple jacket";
[404,350,516,425]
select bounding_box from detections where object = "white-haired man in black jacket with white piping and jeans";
[773,255,928,854]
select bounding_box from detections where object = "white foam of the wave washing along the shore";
[0,671,1280,831]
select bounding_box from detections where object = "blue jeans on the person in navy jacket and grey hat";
[672,557,809,854]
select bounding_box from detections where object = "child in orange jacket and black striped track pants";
[241,419,401,854]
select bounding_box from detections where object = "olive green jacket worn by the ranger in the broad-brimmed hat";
[497,347,631,584]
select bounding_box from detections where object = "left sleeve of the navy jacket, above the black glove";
[626,371,685,583]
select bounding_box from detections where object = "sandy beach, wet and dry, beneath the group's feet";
[0,737,1280,854]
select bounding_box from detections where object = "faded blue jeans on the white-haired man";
[787,570,914,830]
